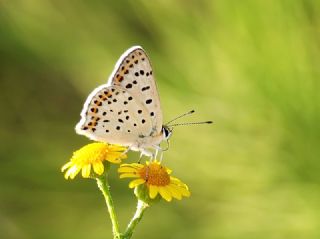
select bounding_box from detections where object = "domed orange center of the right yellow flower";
[139,163,170,186]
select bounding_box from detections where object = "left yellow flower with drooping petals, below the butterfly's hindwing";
[61,143,127,179]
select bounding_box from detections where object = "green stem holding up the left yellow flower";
[96,177,121,239]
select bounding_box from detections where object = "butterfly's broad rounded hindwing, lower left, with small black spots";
[76,85,152,146]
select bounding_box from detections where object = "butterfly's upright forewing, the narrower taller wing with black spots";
[108,46,163,135]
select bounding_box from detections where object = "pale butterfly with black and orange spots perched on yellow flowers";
[76,46,212,157]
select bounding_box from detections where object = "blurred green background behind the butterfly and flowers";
[0,0,320,239]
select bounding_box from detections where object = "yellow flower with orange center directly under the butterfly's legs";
[118,161,190,202]
